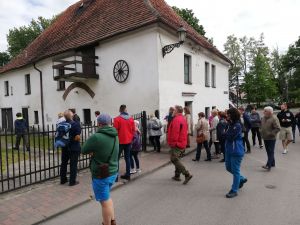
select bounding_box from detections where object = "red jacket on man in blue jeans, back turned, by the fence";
[114,113,135,145]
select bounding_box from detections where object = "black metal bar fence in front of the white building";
[0,111,147,193]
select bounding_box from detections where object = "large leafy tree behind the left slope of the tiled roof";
[7,17,56,57]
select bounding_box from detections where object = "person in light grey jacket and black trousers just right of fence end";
[147,114,162,152]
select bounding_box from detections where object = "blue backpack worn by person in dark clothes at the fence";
[54,121,71,148]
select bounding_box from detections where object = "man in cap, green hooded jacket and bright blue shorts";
[82,114,119,225]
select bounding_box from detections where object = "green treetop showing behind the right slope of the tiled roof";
[172,6,206,37]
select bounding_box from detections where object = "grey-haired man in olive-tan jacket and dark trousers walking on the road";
[261,106,280,171]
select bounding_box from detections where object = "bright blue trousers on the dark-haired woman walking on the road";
[225,153,246,192]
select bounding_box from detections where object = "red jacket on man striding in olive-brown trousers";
[168,114,188,150]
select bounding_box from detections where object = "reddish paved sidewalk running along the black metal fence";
[0,143,195,225]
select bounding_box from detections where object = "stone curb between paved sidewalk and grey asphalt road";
[32,149,196,225]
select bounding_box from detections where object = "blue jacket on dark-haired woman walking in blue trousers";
[225,122,245,157]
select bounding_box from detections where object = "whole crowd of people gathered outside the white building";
[11,104,300,225]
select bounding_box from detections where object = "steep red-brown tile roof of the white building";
[0,0,230,73]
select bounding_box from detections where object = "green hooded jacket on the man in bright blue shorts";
[81,126,119,178]
